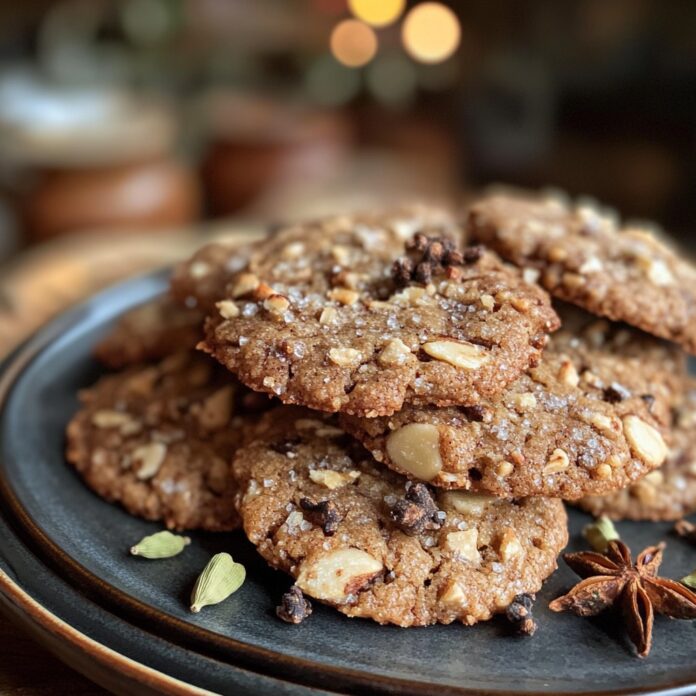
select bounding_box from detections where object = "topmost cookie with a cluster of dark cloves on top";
[202,216,558,416]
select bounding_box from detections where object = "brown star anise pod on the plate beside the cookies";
[549,539,696,657]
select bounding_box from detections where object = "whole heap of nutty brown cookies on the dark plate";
[68,197,696,626]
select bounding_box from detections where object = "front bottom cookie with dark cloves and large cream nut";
[233,407,567,626]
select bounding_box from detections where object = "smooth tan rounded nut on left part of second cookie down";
[387,423,442,481]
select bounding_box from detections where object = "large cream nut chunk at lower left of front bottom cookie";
[296,547,384,604]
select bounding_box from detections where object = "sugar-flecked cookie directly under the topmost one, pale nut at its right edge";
[341,322,683,500]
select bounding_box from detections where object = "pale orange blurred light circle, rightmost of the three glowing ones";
[401,2,461,63]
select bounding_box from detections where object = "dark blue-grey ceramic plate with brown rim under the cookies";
[0,275,696,694]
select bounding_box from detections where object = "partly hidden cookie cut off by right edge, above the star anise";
[578,378,696,522]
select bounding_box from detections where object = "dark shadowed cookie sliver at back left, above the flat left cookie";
[94,295,204,369]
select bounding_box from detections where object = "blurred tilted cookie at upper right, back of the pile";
[468,194,696,353]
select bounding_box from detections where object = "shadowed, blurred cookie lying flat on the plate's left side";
[67,353,266,530]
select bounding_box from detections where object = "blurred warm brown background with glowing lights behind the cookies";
[0,0,696,354]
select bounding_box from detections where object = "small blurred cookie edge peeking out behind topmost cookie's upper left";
[169,242,254,311]
